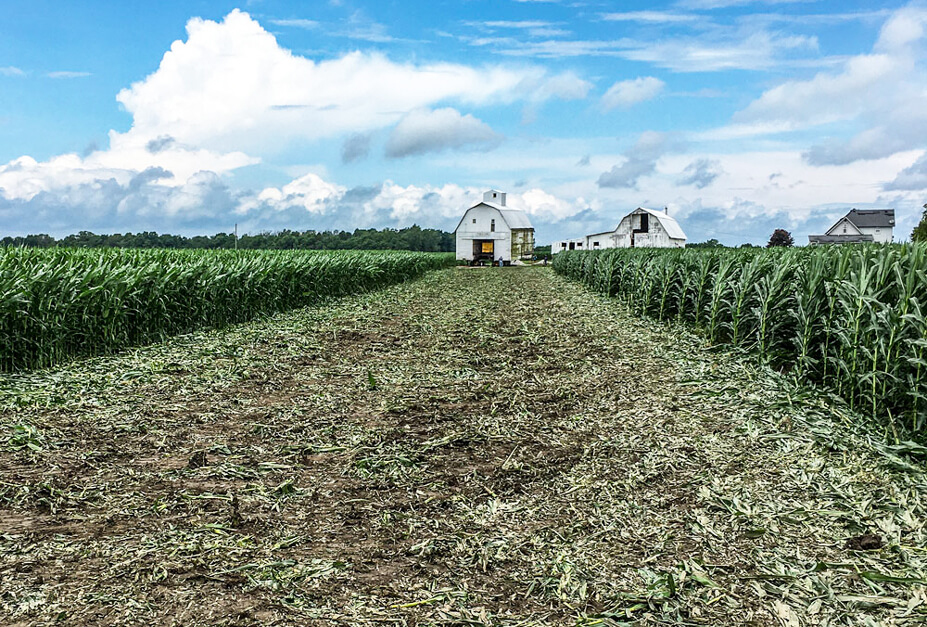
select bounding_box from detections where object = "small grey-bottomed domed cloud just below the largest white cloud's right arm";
[386,107,501,159]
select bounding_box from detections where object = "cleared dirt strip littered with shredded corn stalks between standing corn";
[0,268,927,627]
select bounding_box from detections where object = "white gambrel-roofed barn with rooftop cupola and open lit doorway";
[455,189,534,263]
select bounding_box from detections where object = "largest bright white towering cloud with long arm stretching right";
[117,11,589,152]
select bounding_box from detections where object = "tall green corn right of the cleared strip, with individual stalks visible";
[553,245,927,437]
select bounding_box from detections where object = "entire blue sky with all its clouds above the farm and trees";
[0,0,927,244]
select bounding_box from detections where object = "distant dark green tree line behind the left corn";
[0,225,456,252]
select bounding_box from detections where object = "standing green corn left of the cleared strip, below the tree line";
[0,248,454,372]
